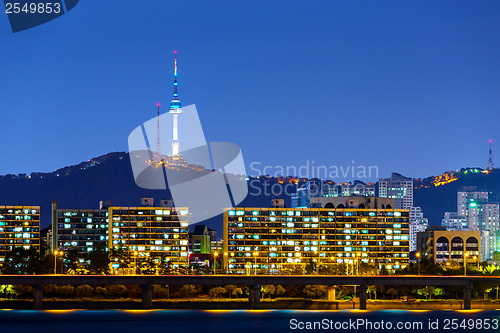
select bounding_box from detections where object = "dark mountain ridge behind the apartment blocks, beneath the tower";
[0,152,500,236]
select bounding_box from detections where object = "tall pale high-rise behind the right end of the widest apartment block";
[378,173,413,209]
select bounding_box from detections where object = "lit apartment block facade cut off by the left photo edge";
[0,206,40,261]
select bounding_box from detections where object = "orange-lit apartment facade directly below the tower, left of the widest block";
[108,207,189,268]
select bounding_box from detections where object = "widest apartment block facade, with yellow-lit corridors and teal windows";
[224,208,409,274]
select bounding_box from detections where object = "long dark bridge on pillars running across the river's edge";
[0,275,500,310]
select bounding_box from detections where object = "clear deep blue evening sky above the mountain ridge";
[0,0,500,182]
